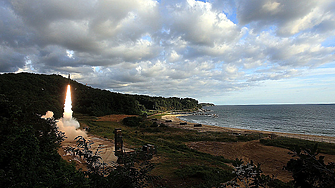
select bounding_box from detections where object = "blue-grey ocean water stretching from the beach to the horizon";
[179,104,335,137]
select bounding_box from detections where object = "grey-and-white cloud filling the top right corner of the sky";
[237,0,334,36]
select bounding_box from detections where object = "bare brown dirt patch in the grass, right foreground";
[187,140,292,182]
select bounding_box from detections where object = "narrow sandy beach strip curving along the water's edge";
[162,114,335,143]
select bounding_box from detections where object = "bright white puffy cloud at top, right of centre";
[168,0,239,46]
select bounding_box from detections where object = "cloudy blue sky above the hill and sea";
[0,0,335,105]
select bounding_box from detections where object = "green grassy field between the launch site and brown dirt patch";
[76,115,244,187]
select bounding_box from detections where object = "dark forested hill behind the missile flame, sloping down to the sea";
[0,73,199,118]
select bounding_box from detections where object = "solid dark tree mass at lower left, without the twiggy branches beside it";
[0,96,86,187]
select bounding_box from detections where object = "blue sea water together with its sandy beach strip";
[162,105,335,143]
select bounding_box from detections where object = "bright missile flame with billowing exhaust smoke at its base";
[41,85,87,142]
